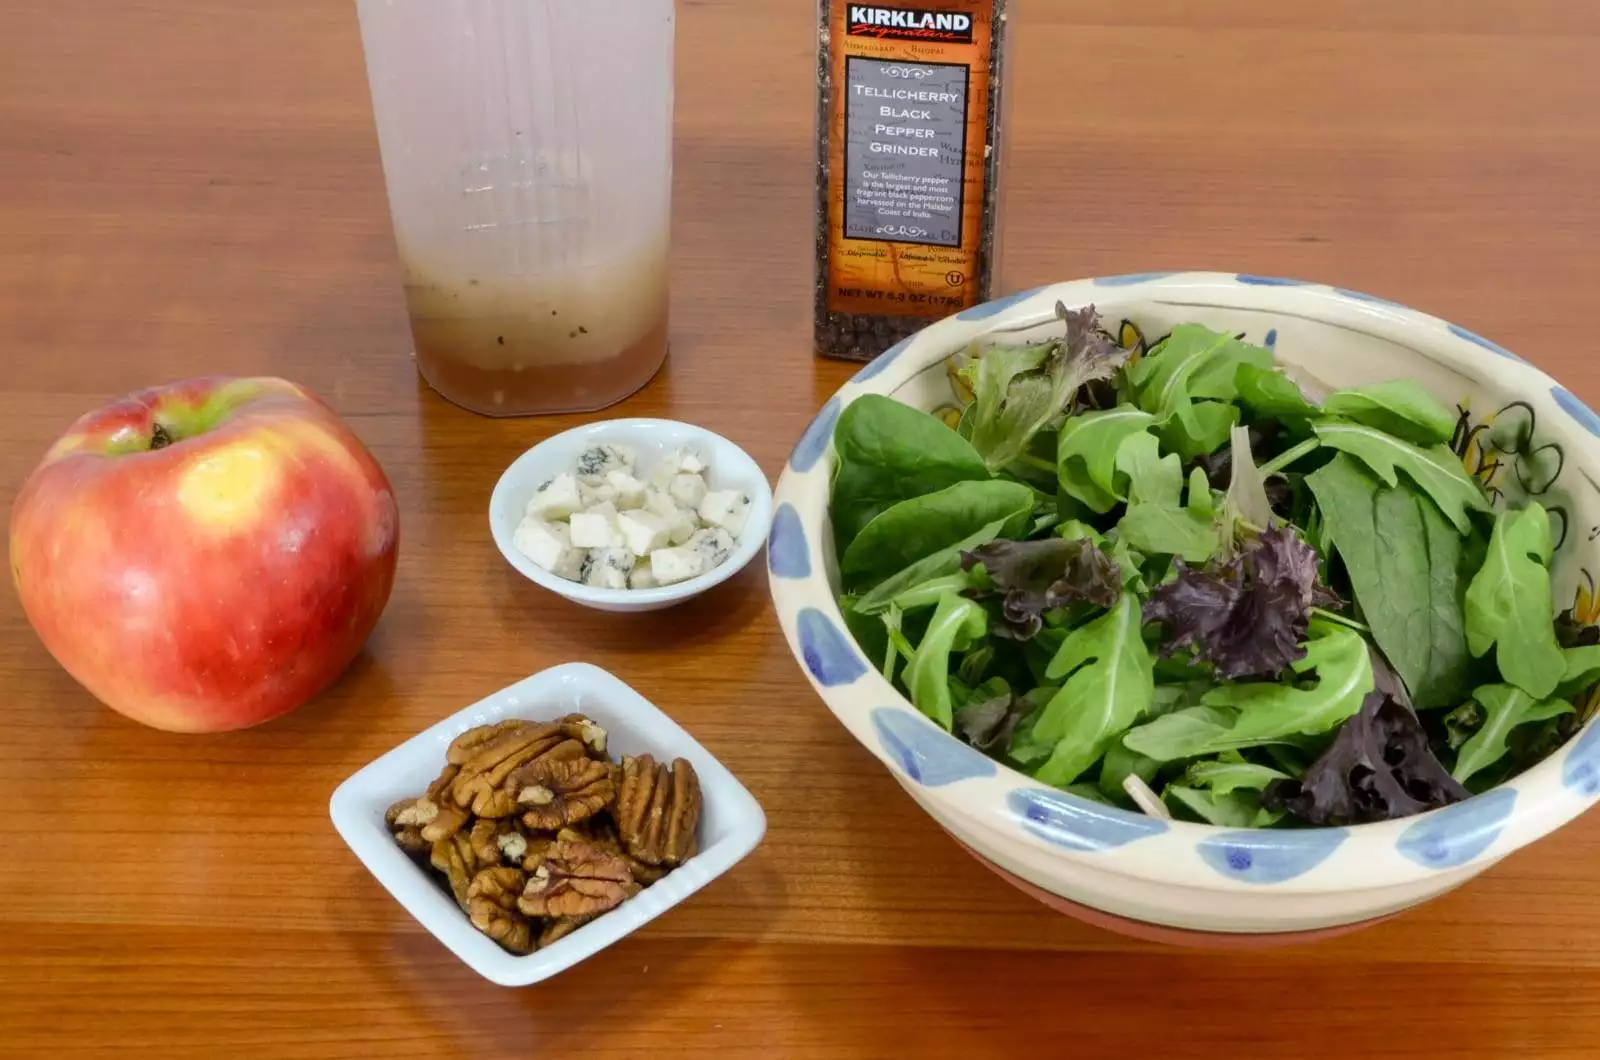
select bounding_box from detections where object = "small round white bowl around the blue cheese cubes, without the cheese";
[490,420,773,612]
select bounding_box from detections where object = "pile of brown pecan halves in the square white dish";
[384,714,701,954]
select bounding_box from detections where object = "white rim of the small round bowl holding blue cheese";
[488,416,773,610]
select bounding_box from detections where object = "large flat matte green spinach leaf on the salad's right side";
[1306,453,1472,708]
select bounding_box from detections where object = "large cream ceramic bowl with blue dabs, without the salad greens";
[768,274,1600,935]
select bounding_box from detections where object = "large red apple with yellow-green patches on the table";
[11,378,400,732]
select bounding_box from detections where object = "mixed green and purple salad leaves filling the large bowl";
[830,304,1600,826]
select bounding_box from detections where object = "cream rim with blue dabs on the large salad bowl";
[768,272,1600,893]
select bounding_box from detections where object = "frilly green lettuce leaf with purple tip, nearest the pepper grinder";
[971,303,1131,471]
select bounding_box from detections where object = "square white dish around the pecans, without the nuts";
[328,663,766,986]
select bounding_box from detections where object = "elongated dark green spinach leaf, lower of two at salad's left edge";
[838,479,1034,586]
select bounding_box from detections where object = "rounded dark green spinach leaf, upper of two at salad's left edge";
[829,394,989,552]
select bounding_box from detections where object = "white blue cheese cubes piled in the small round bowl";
[515,444,750,589]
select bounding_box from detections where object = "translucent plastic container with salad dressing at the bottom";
[357,0,675,416]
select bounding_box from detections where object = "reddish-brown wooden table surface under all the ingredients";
[0,0,1600,1057]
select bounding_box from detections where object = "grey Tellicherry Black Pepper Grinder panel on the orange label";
[843,56,970,247]
